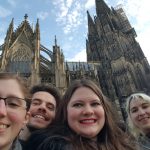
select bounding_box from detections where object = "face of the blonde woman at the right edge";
[130,98,150,133]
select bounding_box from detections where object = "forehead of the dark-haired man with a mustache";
[32,91,56,105]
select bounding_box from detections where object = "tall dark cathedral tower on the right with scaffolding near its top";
[86,0,150,119]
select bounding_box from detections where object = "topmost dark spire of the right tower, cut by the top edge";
[95,0,111,16]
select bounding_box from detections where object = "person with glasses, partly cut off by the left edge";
[0,73,29,150]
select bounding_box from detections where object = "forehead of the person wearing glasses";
[0,79,23,96]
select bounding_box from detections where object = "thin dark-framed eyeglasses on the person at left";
[0,97,27,110]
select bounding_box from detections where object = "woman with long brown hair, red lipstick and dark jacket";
[30,79,136,150]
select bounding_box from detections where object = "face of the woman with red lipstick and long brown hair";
[67,87,105,138]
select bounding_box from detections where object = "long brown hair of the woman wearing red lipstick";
[51,79,134,150]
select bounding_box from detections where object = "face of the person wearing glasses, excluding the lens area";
[0,79,29,150]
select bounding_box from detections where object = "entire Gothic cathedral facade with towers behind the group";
[0,0,150,119]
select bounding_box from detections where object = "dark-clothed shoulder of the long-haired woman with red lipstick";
[38,135,69,150]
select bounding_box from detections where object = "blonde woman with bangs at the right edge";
[126,93,150,150]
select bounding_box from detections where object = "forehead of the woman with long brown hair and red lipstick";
[70,87,99,101]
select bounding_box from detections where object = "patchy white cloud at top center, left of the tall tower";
[53,0,84,34]
